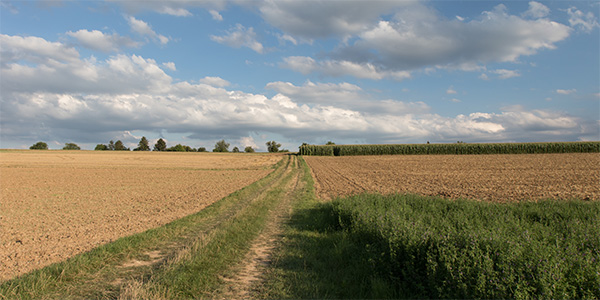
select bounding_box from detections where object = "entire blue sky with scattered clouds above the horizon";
[0,0,600,151]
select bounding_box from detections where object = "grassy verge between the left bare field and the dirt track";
[0,158,289,299]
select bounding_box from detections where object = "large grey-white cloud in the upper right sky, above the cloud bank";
[282,1,571,79]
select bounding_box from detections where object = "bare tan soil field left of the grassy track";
[0,151,282,281]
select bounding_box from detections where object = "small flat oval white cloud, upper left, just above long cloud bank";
[67,29,140,52]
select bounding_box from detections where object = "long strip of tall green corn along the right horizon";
[300,142,600,156]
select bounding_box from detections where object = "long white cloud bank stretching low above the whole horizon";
[0,35,598,149]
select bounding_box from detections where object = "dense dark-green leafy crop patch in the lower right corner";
[333,194,600,299]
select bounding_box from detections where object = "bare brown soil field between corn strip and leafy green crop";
[304,153,600,202]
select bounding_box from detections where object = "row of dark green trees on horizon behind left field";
[29,136,289,153]
